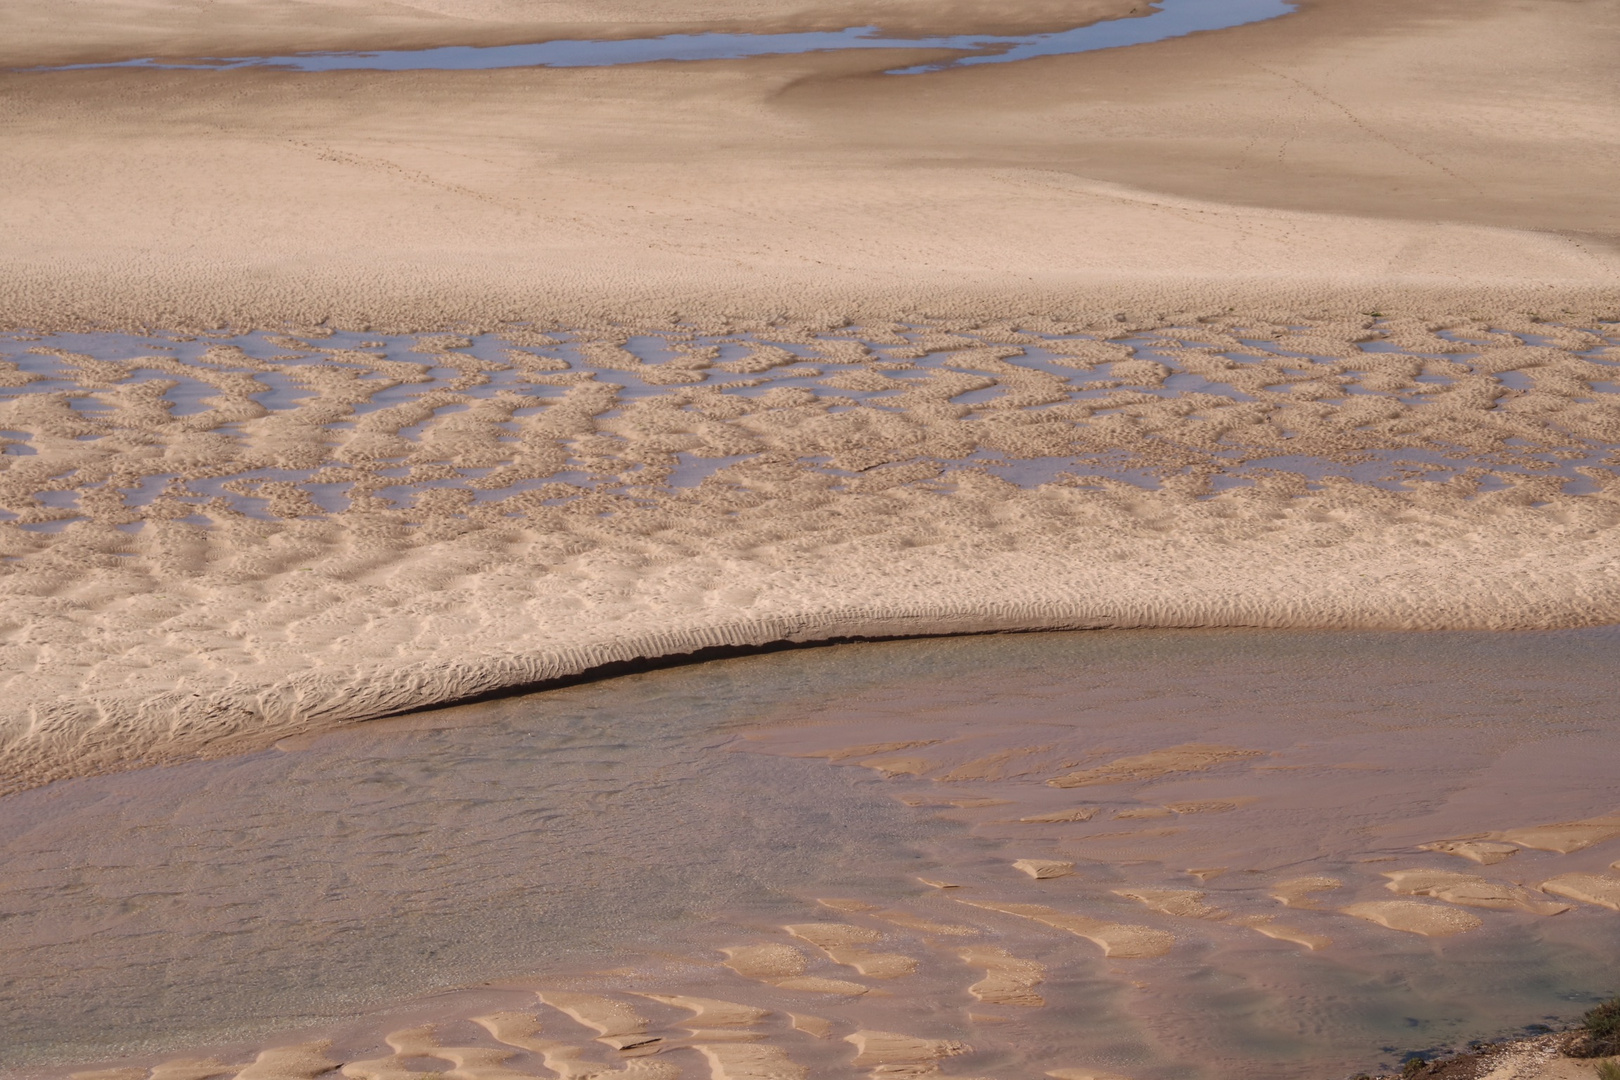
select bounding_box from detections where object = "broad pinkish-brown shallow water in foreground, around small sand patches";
[9,630,1620,1080]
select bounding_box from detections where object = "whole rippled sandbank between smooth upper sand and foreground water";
[0,316,1620,789]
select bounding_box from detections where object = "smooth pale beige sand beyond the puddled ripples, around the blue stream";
[0,0,1620,329]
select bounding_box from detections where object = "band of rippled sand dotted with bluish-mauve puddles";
[0,321,1620,533]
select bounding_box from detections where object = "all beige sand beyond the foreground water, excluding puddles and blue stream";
[0,0,1620,790]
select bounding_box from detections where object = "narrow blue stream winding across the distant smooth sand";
[36,0,1294,74]
